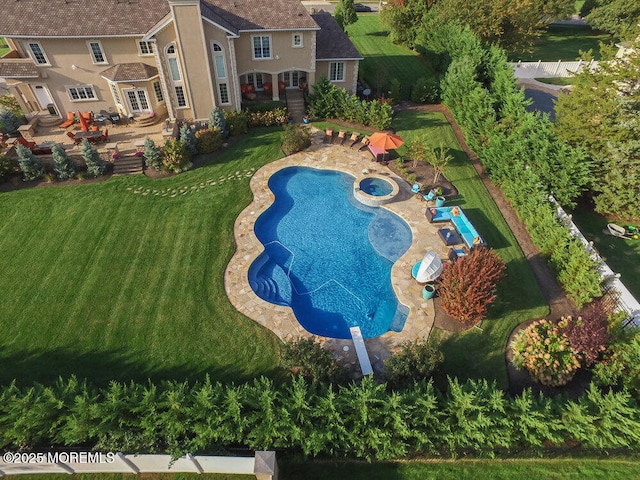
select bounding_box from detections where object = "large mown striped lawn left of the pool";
[0,129,282,384]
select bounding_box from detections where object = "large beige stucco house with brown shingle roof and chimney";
[0,0,362,121]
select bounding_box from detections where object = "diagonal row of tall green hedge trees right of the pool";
[434,27,602,307]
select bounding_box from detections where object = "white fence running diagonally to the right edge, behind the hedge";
[549,197,640,327]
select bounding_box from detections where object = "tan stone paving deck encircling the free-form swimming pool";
[224,131,448,372]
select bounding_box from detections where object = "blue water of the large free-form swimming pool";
[249,167,412,338]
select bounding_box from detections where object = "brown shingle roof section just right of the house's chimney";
[200,0,318,32]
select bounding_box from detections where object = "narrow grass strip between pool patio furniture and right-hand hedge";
[393,110,548,388]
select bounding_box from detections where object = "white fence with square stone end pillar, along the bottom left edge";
[0,451,278,480]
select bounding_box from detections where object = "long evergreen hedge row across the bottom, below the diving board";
[0,377,640,460]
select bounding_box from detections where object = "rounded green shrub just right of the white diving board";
[384,340,443,389]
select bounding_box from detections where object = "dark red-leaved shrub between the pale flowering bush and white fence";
[563,300,610,367]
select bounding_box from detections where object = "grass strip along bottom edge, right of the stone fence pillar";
[280,459,640,480]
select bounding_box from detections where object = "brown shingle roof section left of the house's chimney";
[0,0,169,37]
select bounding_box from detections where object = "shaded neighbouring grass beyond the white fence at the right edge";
[572,210,640,298]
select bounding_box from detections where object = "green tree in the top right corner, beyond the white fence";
[585,0,640,40]
